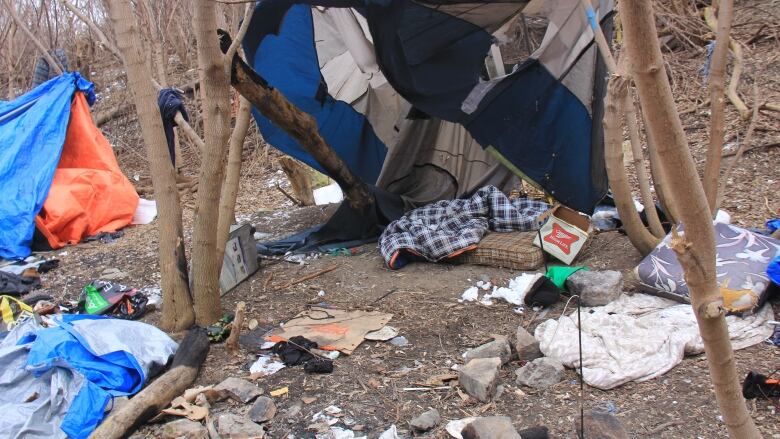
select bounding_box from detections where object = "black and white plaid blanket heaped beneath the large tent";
[379,186,550,269]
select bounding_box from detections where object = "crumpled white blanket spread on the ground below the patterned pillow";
[534,294,774,390]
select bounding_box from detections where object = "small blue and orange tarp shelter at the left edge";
[0,73,138,259]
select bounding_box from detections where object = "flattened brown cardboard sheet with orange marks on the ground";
[267,307,393,355]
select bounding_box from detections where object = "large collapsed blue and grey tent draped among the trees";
[244,0,613,213]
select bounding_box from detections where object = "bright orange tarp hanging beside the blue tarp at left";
[35,92,138,248]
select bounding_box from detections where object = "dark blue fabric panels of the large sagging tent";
[244,0,607,213]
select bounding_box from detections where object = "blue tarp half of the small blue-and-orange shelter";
[0,73,95,259]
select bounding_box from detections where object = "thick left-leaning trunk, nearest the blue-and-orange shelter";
[108,0,195,331]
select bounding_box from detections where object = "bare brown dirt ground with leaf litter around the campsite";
[19,0,780,438]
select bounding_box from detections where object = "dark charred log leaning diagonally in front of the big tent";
[220,31,374,211]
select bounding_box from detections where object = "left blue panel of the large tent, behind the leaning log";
[244,1,387,184]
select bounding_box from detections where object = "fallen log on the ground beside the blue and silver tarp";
[89,327,209,439]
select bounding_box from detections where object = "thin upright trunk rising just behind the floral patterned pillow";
[702,0,734,214]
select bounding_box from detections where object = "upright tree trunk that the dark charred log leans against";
[192,0,230,324]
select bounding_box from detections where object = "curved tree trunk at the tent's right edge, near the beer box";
[604,76,659,256]
